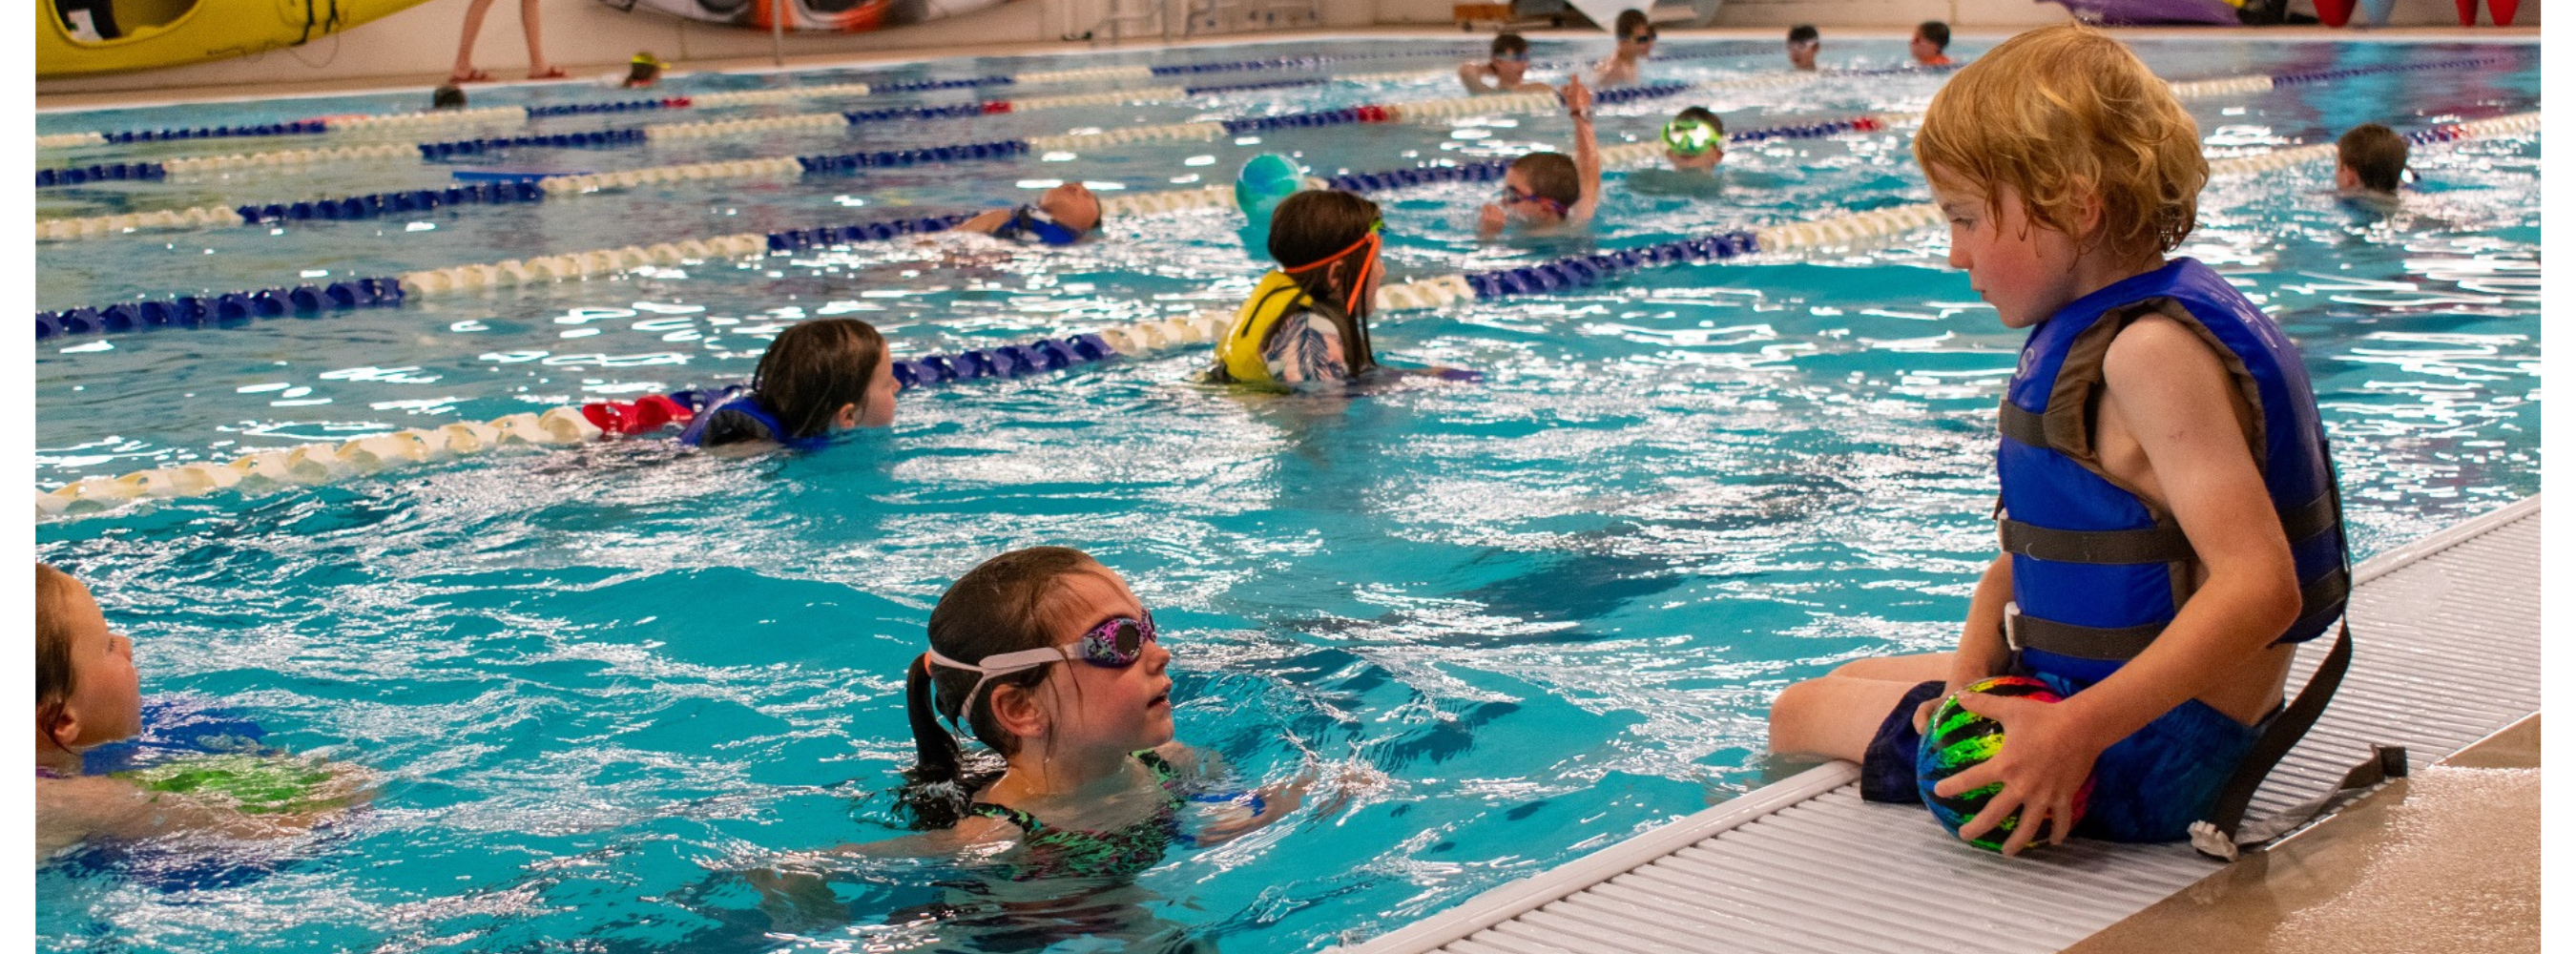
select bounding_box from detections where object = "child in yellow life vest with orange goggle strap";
[1206,191,1386,386]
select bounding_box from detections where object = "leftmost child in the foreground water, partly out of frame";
[31,562,365,863]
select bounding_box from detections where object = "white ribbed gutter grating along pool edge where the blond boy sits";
[1342,495,2540,954]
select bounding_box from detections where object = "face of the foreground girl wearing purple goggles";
[1038,568,1173,753]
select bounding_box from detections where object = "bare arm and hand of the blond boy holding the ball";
[1935,317,2300,854]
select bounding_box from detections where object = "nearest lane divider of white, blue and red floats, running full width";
[36,111,2540,521]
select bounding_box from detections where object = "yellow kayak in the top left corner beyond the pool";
[33,0,427,80]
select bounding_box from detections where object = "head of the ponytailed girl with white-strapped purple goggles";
[904,547,1173,804]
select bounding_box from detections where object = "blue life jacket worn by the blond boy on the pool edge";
[1997,258,2352,686]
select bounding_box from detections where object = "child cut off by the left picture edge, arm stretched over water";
[31,562,350,863]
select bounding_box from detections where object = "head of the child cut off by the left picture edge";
[33,562,142,774]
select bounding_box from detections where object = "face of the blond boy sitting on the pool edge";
[1927,168,2082,327]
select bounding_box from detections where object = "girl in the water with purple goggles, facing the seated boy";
[906,547,1306,877]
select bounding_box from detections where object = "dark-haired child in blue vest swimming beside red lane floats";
[698,317,886,446]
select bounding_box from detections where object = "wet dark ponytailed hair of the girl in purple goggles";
[902,547,1108,828]
